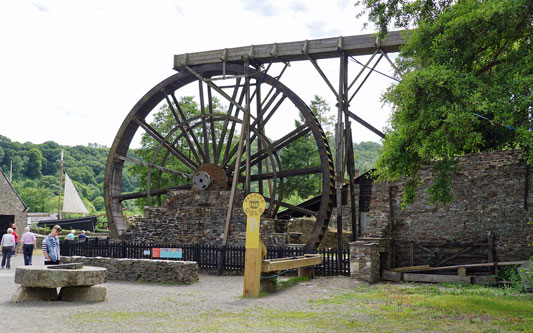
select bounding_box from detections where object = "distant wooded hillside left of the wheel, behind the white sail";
[0,135,138,215]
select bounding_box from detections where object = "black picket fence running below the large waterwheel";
[61,238,350,276]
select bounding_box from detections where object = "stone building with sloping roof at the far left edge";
[0,169,28,237]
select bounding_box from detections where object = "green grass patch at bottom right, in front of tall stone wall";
[312,285,533,331]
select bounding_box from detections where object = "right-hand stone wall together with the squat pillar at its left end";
[350,150,533,281]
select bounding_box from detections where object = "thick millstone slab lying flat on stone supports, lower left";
[15,266,107,288]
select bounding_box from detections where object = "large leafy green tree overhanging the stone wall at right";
[358,0,533,205]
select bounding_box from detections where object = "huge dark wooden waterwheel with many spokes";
[104,64,334,247]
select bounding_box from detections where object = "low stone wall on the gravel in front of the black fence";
[61,257,198,284]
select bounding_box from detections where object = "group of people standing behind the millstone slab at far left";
[0,224,87,269]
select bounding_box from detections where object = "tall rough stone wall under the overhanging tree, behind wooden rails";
[363,150,533,266]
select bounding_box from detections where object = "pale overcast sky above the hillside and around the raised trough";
[0,0,392,147]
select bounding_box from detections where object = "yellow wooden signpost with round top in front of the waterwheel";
[242,193,266,297]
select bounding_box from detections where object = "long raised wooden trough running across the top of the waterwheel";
[174,31,405,70]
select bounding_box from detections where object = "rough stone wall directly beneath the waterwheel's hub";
[132,190,287,245]
